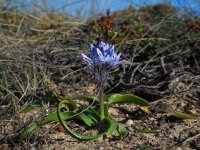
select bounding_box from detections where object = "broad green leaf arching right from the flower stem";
[108,94,149,106]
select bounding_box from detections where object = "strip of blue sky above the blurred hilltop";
[1,0,200,20]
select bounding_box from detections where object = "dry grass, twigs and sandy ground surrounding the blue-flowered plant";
[0,0,200,149]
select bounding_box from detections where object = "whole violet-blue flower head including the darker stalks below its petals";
[82,41,121,83]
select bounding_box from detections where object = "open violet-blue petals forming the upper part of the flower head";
[82,41,121,68]
